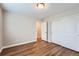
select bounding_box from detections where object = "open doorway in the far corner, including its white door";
[36,20,48,42]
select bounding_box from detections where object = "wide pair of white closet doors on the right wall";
[52,16,75,49]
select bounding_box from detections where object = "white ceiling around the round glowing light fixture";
[2,3,79,19]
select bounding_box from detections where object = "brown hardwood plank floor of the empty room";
[1,41,79,56]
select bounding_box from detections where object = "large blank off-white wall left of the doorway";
[3,12,35,47]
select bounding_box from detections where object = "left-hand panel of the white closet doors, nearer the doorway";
[51,19,65,44]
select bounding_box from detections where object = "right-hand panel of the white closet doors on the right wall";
[63,16,76,50]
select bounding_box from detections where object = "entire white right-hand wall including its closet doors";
[45,13,79,51]
